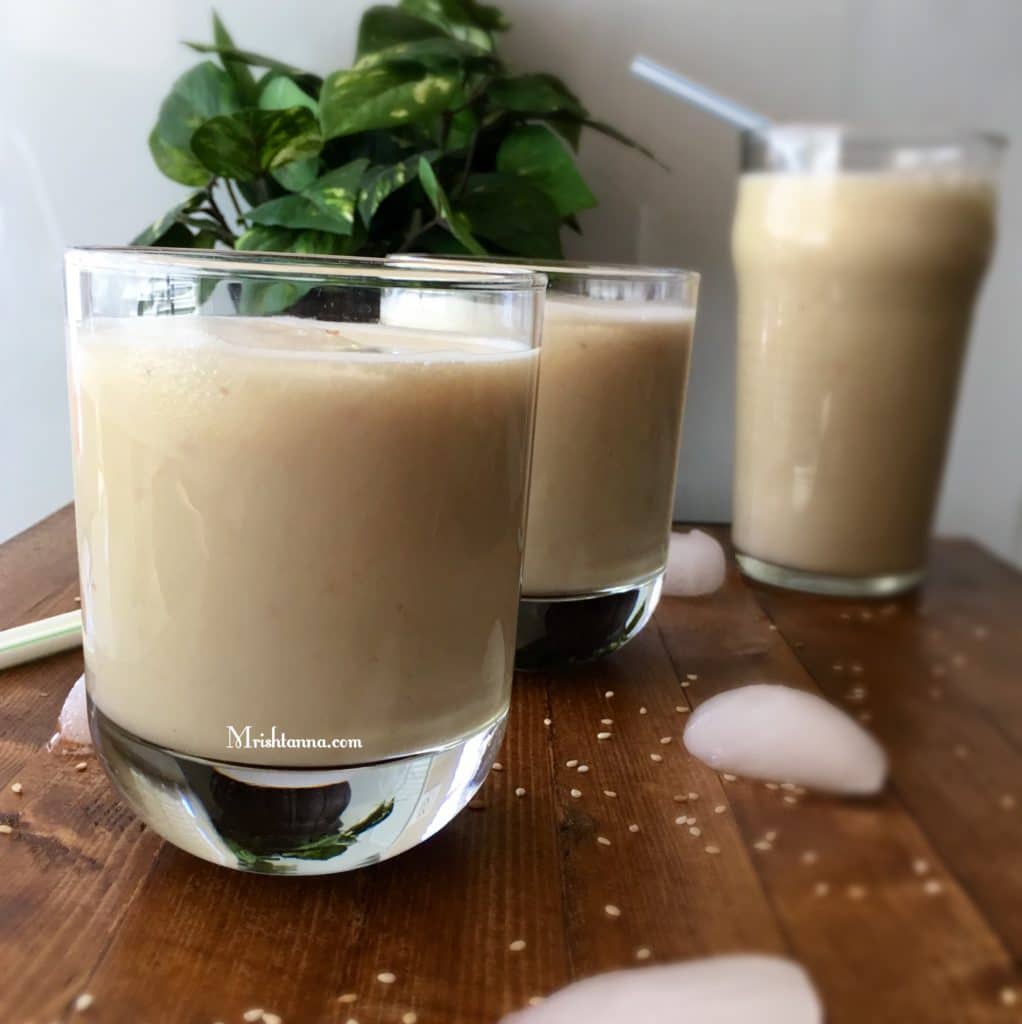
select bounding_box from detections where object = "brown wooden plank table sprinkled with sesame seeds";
[0,510,1022,1024]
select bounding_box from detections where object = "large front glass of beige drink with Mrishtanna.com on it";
[66,249,546,874]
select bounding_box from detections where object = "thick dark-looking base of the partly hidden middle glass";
[514,572,664,672]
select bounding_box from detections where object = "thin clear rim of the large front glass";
[63,246,547,294]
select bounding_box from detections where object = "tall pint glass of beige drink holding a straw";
[732,125,1004,597]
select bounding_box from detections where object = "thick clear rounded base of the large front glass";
[89,700,507,874]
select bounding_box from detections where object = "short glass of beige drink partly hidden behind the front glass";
[387,257,698,670]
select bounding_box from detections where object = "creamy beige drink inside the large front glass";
[71,316,538,767]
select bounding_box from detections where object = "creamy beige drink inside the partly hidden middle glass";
[522,292,694,597]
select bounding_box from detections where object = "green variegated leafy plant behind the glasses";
[133,0,649,280]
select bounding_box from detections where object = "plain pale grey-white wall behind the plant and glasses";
[0,0,1022,564]
